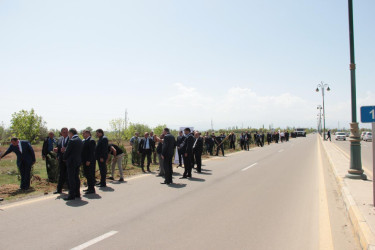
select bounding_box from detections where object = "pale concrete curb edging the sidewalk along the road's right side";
[320,137,375,250]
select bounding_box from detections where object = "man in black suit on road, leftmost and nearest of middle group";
[161,128,176,184]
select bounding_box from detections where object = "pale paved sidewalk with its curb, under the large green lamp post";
[319,137,375,250]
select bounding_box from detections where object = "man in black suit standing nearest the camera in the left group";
[64,128,83,201]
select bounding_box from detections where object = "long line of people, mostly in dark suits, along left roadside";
[0,127,289,200]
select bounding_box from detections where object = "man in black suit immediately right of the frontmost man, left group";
[81,130,96,194]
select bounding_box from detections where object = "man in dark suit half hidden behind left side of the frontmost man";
[53,128,69,194]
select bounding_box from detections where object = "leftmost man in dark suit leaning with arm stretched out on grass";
[0,138,35,190]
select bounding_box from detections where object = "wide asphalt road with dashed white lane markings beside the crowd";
[0,135,359,250]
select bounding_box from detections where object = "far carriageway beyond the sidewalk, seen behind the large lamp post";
[332,136,373,175]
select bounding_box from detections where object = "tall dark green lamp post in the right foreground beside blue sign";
[346,0,367,180]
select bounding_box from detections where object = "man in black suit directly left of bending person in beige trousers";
[95,129,108,187]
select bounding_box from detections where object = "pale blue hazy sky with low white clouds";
[0,0,375,130]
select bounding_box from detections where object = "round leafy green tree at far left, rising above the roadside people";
[10,109,45,143]
